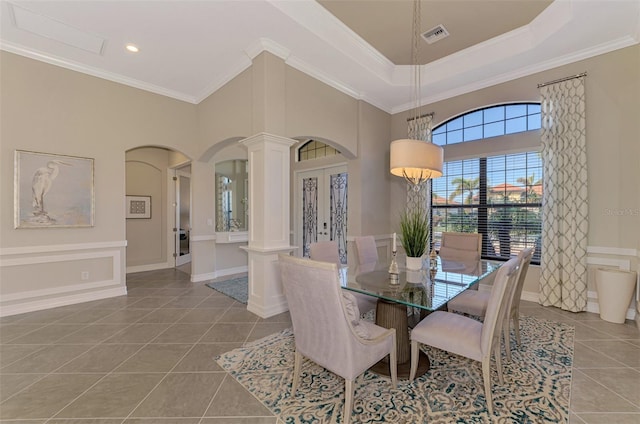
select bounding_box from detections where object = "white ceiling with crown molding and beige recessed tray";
[0,0,640,113]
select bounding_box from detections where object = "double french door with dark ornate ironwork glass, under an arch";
[295,165,348,264]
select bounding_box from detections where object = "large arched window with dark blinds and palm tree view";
[431,103,542,263]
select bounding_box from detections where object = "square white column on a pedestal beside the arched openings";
[241,133,296,318]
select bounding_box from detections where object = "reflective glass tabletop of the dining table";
[342,258,502,311]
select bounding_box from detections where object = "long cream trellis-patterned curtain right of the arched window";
[540,77,589,312]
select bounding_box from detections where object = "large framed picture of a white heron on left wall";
[14,150,95,229]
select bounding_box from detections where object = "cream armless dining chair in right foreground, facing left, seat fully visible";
[409,258,518,414]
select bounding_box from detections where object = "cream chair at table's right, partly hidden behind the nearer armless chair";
[447,247,533,360]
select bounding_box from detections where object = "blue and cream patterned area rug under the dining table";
[216,317,574,424]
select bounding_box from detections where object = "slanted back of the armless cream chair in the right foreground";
[480,258,519,355]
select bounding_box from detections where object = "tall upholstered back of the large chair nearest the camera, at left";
[278,254,368,377]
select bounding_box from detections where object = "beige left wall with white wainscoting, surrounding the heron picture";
[0,51,197,315]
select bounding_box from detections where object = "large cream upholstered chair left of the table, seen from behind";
[278,254,398,423]
